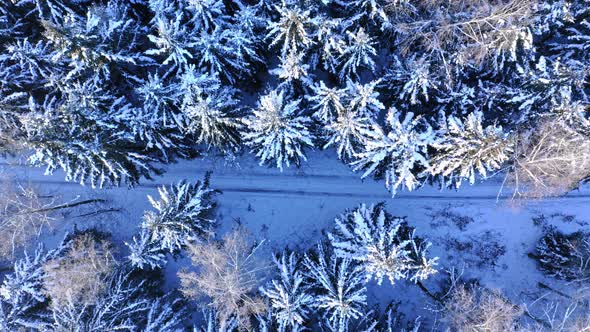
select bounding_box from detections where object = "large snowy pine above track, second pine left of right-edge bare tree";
[351,108,434,196]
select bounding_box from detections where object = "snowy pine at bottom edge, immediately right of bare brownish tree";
[261,253,313,332]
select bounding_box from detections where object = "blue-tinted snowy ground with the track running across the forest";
[0,151,590,328]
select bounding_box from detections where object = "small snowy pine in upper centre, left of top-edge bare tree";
[338,28,377,81]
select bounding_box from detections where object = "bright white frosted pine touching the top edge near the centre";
[266,1,314,56]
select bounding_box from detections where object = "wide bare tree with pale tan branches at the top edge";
[394,0,536,78]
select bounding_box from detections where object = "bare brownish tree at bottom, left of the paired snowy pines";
[178,229,270,329]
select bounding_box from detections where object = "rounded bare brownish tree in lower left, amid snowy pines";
[43,232,116,306]
